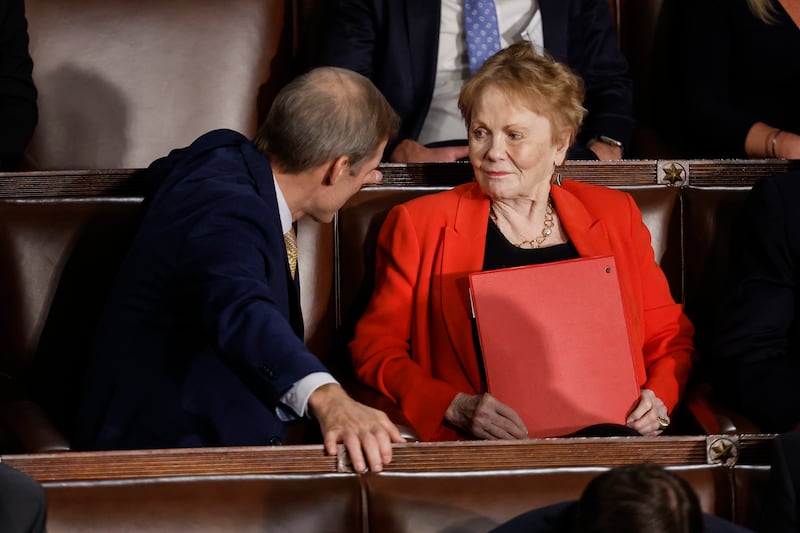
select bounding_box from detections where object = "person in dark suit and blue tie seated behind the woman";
[317,0,633,162]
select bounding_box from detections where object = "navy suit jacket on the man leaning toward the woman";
[76,130,326,449]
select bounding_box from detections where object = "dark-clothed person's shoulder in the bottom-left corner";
[0,463,47,533]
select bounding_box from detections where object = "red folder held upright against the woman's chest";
[470,256,640,437]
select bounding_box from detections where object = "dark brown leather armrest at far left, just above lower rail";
[0,400,71,453]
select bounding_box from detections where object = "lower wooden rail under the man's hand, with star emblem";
[1,435,773,482]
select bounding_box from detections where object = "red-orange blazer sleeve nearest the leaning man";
[350,205,459,440]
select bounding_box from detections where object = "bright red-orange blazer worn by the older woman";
[350,181,694,440]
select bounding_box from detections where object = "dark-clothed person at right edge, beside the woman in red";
[711,172,800,432]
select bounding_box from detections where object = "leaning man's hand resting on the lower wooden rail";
[308,383,405,473]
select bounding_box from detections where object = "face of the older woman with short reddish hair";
[467,87,569,199]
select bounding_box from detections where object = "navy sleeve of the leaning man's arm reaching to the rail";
[176,194,327,405]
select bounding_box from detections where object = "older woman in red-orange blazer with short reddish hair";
[350,43,693,440]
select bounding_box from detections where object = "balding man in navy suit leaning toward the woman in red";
[77,67,403,471]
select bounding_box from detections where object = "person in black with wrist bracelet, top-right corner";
[683,0,800,159]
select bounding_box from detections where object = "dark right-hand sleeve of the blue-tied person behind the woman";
[568,0,633,147]
